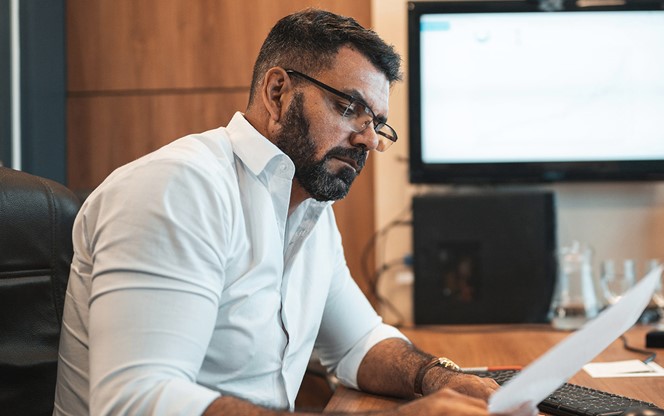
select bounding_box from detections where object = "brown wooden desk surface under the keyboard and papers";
[325,325,664,412]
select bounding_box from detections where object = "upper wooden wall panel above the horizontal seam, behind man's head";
[67,0,370,91]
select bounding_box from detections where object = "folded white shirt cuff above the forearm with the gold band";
[336,323,410,390]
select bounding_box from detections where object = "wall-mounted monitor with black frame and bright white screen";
[409,1,664,183]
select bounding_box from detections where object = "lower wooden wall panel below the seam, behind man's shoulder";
[67,92,248,190]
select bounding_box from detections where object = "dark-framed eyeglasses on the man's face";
[286,69,397,152]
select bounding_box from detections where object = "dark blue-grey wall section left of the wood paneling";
[0,0,67,183]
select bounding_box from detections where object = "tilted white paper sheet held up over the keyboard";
[489,266,662,413]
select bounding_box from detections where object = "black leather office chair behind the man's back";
[0,167,80,416]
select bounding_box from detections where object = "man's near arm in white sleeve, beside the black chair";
[83,158,233,415]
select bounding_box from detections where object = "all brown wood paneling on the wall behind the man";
[67,0,374,300]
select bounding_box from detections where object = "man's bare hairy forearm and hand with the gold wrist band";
[357,338,498,401]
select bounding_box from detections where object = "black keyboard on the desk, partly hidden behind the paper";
[470,370,658,416]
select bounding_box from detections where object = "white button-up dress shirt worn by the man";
[54,113,403,416]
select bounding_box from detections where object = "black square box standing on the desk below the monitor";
[413,191,557,324]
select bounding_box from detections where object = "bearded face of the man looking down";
[274,48,389,201]
